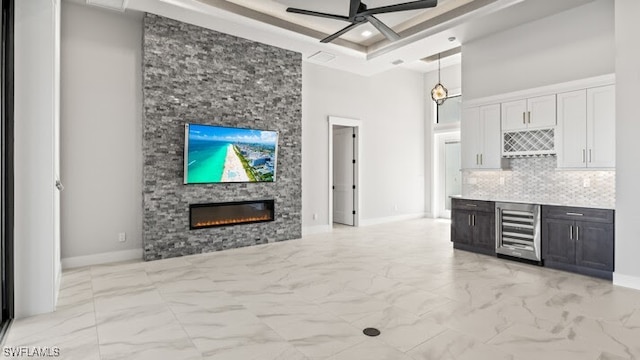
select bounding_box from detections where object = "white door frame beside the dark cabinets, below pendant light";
[433,129,462,219]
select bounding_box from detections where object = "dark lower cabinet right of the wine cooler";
[542,206,615,280]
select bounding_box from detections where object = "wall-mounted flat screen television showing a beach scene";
[184,124,278,184]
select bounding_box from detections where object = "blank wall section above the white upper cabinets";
[462,0,615,100]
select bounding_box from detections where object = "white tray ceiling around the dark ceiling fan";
[84,0,594,75]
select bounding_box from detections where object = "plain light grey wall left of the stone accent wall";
[61,2,142,266]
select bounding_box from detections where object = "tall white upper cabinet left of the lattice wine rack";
[461,104,502,169]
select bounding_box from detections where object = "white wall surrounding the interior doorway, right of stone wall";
[302,62,425,229]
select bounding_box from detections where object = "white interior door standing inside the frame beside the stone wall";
[333,126,355,226]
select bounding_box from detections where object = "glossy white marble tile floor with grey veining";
[3,219,640,360]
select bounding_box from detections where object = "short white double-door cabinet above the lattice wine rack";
[502,95,556,132]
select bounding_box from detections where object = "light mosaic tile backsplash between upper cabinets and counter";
[462,157,616,209]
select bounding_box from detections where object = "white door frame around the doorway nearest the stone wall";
[327,116,362,228]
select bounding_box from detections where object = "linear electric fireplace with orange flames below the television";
[189,200,274,230]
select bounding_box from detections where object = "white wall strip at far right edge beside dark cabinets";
[613,0,640,289]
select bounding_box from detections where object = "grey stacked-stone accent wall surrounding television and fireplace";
[142,14,302,260]
